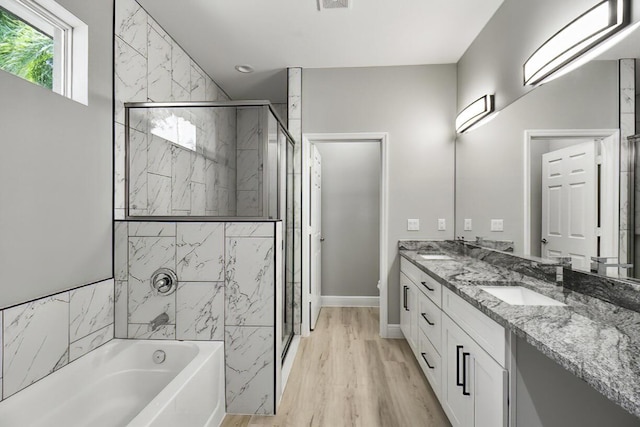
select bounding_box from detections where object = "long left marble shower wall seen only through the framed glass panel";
[129,108,236,216]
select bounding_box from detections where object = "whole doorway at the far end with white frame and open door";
[302,133,388,337]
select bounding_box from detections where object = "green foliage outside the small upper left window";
[0,8,53,89]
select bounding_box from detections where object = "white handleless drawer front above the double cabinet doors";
[442,289,506,367]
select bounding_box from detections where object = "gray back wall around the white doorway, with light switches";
[302,65,456,324]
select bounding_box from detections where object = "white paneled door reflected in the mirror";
[541,142,598,270]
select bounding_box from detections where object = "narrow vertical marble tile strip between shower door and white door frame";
[287,68,302,334]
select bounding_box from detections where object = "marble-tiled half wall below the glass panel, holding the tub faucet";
[114,221,282,414]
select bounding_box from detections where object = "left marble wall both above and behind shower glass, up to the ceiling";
[114,0,236,219]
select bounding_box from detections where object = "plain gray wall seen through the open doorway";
[316,142,380,296]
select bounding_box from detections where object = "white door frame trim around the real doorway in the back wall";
[301,132,389,338]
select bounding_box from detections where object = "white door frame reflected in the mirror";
[523,129,628,255]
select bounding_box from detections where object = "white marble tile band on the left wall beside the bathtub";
[0,279,114,400]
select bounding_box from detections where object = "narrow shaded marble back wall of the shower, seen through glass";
[236,107,264,217]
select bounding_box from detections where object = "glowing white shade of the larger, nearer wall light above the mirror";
[523,0,630,85]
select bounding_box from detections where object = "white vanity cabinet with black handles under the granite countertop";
[400,258,508,427]
